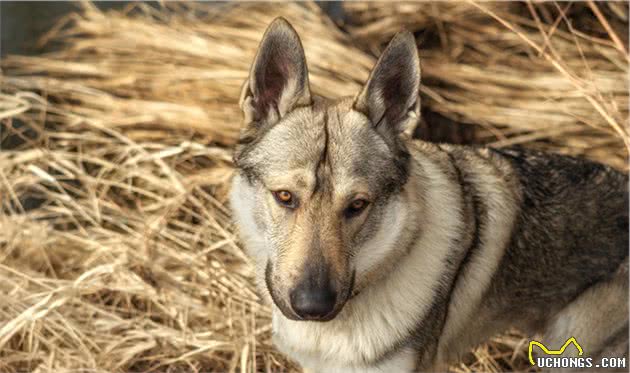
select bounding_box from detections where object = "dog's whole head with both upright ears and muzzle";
[232,19,420,321]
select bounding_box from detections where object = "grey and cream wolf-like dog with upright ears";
[230,18,628,372]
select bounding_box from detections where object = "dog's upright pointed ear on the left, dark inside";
[240,17,311,125]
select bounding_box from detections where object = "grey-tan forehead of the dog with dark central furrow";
[258,101,392,194]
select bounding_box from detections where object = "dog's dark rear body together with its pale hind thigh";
[488,149,629,371]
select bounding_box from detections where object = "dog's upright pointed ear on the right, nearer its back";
[354,32,420,136]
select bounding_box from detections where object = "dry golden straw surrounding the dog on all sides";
[0,3,628,372]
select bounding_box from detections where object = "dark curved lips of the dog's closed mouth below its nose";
[265,262,356,322]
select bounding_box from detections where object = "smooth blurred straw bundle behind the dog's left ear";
[3,4,374,145]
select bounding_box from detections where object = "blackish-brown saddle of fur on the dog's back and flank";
[489,145,628,312]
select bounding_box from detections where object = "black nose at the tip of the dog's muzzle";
[289,286,337,320]
